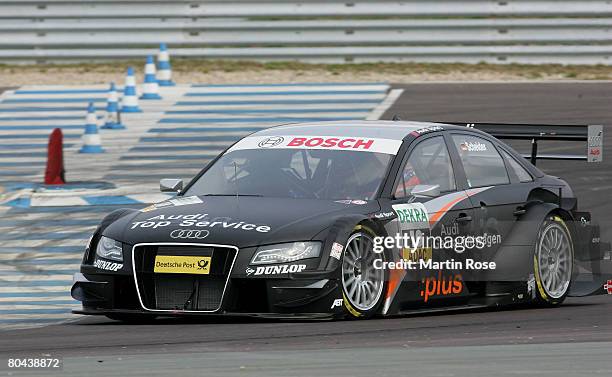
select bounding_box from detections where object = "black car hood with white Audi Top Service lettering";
[103,196,380,248]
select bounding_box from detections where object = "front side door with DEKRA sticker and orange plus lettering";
[384,134,473,305]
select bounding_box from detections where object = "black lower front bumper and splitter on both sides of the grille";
[71,266,342,318]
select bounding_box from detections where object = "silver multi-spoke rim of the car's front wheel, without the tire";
[342,233,384,311]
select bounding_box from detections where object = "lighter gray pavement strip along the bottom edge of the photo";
[9,342,612,377]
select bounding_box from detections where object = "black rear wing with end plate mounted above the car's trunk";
[441,122,603,165]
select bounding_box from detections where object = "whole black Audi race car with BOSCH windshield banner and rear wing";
[72,121,610,320]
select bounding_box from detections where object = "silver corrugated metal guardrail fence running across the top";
[0,0,612,65]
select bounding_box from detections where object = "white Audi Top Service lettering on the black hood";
[130,213,271,233]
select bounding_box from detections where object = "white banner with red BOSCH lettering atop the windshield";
[228,135,402,154]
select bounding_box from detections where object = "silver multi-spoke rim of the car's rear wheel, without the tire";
[537,224,572,298]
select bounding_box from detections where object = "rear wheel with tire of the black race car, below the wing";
[533,215,574,307]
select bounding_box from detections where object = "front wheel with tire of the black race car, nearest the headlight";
[340,225,388,319]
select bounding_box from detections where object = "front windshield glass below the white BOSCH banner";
[185,149,392,200]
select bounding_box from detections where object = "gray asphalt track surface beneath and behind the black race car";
[0,83,612,376]
